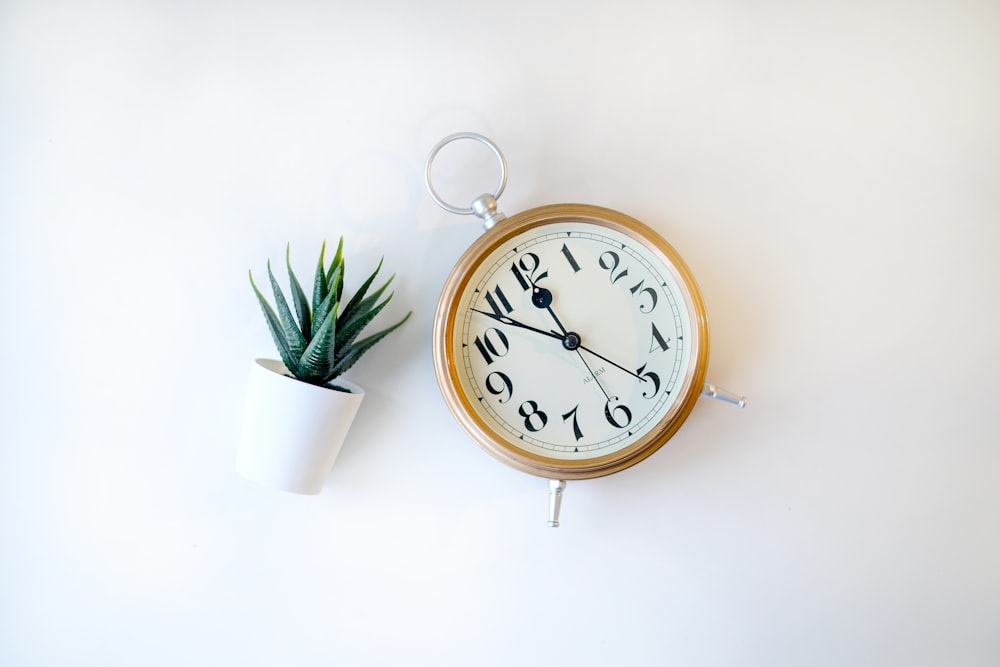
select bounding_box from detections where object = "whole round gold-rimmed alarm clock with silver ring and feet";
[426,133,744,526]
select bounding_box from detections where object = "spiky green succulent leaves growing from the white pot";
[250,237,413,385]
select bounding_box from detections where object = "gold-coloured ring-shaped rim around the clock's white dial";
[433,204,709,479]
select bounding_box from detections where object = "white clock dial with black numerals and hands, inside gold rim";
[445,220,698,462]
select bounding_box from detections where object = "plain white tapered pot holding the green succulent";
[236,359,365,494]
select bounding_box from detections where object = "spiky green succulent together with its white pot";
[236,238,412,494]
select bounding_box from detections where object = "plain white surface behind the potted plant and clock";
[0,0,1000,667]
